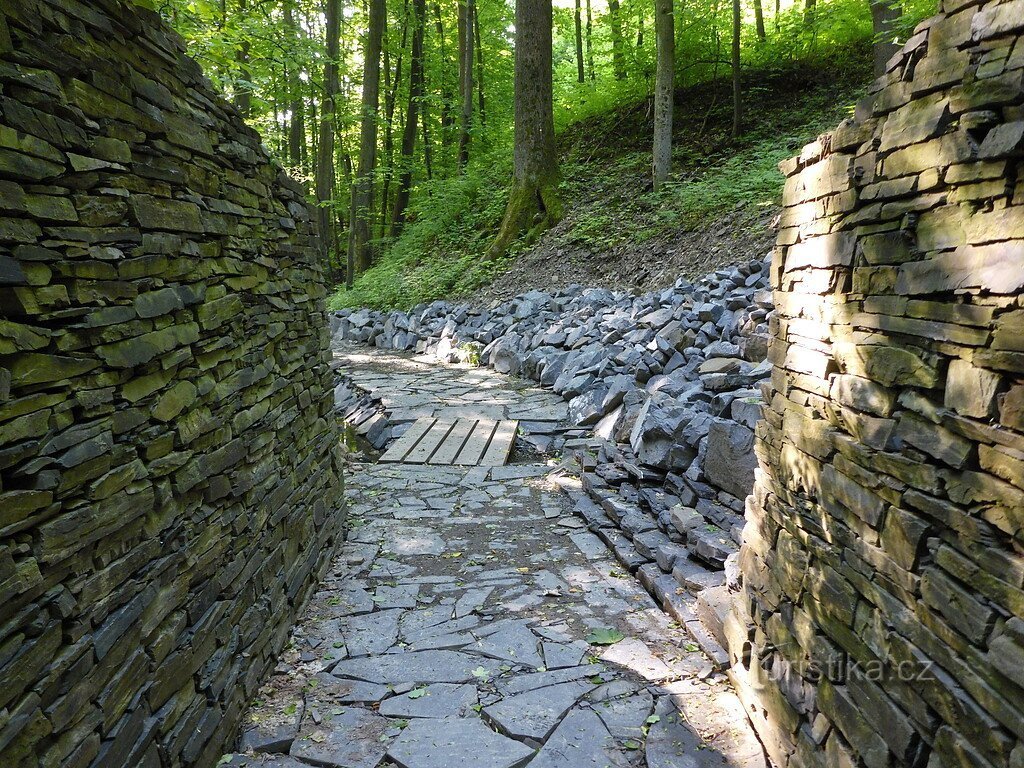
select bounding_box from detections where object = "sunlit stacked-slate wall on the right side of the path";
[727,0,1024,768]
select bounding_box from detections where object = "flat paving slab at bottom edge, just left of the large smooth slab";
[289,707,390,768]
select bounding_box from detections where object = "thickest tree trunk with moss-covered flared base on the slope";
[486,0,562,259]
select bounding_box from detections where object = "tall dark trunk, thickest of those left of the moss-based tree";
[349,0,385,273]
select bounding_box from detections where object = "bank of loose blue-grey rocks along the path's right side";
[332,260,773,664]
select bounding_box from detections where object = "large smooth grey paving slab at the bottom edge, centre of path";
[387,717,534,768]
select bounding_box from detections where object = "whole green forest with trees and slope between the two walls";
[153,0,935,308]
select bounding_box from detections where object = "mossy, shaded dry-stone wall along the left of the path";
[0,0,342,768]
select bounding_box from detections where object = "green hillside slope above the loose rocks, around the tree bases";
[332,46,869,309]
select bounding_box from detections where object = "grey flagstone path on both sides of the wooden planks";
[224,349,764,768]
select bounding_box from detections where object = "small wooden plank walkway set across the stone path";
[380,418,519,467]
